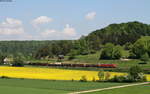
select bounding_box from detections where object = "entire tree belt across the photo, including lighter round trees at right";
[0,21,150,59]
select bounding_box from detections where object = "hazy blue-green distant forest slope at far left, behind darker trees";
[0,41,51,55]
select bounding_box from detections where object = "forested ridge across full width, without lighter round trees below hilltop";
[0,22,150,57]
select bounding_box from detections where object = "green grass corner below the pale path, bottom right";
[84,84,150,94]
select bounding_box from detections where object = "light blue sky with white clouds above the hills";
[0,0,150,40]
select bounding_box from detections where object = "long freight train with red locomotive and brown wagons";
[28,63,117,68]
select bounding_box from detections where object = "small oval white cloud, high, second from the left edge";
[32,16,53,26]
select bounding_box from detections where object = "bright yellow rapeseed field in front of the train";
[0,66,150,81]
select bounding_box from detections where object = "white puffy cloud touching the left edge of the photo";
[0,18,24,35]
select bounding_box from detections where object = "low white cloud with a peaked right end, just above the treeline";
[40,24,76,40]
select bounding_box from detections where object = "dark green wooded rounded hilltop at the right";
[86,21,150,45]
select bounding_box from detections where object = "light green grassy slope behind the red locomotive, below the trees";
[68,53,150,68]
